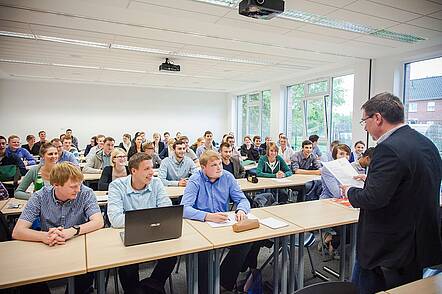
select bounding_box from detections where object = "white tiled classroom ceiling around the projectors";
[0,0,442,92]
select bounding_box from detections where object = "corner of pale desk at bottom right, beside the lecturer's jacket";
[385,274,442,294]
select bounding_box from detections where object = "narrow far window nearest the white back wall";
[237,90,272,142]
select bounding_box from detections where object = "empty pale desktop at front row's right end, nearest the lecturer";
[264,200,359,231]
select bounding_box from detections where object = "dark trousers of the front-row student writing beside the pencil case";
[198,243,259,294]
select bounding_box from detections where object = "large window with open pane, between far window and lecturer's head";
[287,75,354,152]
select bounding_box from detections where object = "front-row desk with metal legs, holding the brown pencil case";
[188,208,304,294]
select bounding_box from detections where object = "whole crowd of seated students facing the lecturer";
[0,130,373,293]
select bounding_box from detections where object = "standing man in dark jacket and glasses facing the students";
[342,93,442,293]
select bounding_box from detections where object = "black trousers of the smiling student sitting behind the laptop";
[118,257,177,294]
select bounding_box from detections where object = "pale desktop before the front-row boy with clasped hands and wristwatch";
[0,236,86,289]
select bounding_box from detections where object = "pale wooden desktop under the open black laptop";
[86,220,213,271]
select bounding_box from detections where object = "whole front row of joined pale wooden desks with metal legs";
[0,200,358,293]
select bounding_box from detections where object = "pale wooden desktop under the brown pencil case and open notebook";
[187,208,304,248]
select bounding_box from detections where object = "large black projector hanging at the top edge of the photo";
[239,0,284,19]
